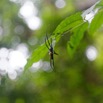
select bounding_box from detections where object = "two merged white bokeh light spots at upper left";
[19,1,41,30]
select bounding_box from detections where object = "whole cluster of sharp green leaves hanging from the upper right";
[25,0,103,70]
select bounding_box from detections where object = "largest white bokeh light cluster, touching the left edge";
[0,43,29,80]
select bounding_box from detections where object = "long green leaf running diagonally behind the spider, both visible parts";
[25,12,83,70]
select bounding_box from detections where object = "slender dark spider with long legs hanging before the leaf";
[45,34,58,68]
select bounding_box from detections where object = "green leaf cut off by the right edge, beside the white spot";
[89,10,103,34]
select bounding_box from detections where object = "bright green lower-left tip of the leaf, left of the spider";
[25,44,48,70]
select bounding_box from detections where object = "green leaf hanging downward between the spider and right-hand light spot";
[67,22,88,58]
